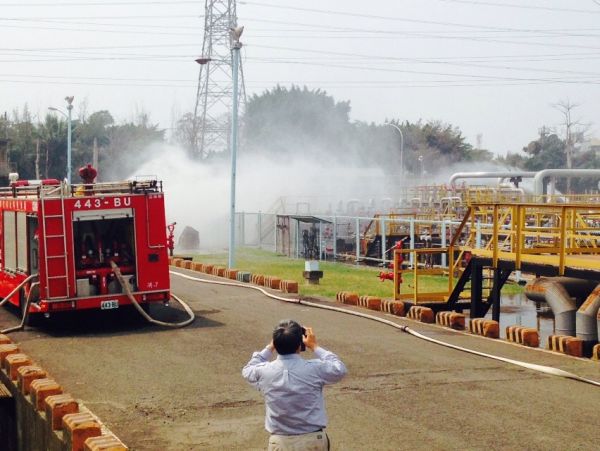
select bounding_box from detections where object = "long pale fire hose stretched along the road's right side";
[169,271,600,387]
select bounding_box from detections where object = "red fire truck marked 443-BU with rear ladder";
[0,167,170,314]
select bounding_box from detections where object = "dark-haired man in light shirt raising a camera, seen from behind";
[242,320,347,451]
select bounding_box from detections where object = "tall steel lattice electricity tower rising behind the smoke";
[192,0,246,158]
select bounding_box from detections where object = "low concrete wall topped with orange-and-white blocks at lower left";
[0,335,128,451]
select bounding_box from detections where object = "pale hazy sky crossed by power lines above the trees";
[0,0,600,155]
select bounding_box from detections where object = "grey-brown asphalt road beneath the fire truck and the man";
[0,270,600,451]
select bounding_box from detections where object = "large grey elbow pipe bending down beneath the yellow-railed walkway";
[525,277,595,336]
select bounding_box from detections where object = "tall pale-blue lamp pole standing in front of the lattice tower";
[227,27,244,269]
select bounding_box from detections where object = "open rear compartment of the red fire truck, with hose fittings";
[73,214,136,297]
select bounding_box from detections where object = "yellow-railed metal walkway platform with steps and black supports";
[394,201,600,320]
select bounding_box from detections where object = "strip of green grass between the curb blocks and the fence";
[185,248,523,298]
